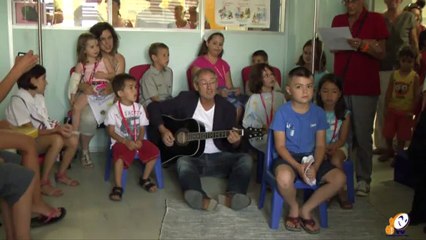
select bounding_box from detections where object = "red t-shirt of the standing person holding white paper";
[331,9,389,96]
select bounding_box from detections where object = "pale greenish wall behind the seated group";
[0,0,343,150]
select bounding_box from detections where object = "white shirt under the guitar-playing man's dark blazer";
[192,100,220,153]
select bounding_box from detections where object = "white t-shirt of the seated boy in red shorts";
[104,101,149,147]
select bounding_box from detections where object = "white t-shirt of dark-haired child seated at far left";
[6,89,58,129]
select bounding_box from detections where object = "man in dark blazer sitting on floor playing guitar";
[148,68,252,210]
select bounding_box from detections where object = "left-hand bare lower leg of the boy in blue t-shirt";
[275,164,299,219]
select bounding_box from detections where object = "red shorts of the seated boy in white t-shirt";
[112,139,160,168]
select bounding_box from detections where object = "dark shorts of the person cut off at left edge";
[0,163,34,206]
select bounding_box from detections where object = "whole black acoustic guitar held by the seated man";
[160,115,266,165]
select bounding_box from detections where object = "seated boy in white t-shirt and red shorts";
[105,74,160,201]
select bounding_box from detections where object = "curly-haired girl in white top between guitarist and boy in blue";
[243,63,285,152]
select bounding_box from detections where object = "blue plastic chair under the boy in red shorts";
[104,140,164,192]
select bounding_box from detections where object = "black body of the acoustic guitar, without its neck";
[160,115,205,164]
